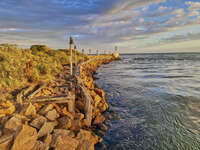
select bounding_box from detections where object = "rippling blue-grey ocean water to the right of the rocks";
[96,53,200,150]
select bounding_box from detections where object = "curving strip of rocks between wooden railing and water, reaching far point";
[80,56,115,130]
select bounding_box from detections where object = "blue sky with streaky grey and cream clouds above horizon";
[0,0,200,53]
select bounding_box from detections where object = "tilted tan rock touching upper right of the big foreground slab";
[38,122,55,138]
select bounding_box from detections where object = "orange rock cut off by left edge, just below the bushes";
[0,100,15,115]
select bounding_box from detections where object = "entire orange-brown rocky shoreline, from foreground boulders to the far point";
[0,55,119,150]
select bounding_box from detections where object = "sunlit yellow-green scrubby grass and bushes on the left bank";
[0,44,88,100]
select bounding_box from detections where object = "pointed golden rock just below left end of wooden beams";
[20,103,36,117]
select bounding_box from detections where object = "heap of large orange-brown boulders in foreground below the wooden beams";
[0,103,99,150]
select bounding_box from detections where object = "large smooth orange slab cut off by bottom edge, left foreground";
[11,125,37,150]
